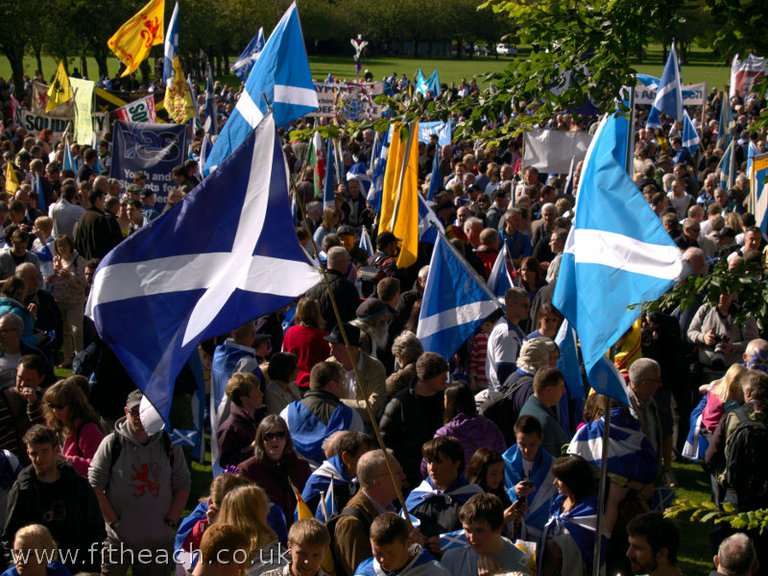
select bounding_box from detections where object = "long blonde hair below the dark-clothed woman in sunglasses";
[216,484,277,551]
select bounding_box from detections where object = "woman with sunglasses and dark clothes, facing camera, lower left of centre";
[237,414,310,525]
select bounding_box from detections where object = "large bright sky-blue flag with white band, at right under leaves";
[552,115,684,396]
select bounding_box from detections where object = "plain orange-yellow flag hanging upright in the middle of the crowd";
[379,122,419,268]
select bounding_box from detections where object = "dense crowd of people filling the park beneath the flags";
[0,67,768,576]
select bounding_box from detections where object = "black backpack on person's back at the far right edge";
[725,407,768,511]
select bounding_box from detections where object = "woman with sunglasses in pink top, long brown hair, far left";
[43,376,104,478]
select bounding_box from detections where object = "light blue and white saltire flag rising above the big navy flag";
[205,2,318,172]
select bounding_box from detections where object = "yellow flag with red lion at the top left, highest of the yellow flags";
[107,0,165,76]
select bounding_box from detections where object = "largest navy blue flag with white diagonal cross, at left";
[87,115,320,420]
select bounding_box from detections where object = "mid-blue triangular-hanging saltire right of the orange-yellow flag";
[416,234,499,358]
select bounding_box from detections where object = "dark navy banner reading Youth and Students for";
[110,121,187,210]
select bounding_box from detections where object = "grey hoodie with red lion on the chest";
[88,417,191,547]
